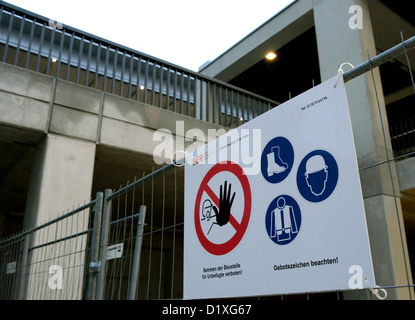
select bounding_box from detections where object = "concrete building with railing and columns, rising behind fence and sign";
[0,0,415,299]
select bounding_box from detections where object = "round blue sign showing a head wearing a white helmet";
[297,150,339,203]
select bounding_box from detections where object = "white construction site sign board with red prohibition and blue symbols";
[184,77,375,299]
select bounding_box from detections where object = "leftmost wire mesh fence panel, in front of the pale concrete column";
[0,198,102,300]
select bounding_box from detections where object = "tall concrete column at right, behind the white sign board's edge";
[313,0,414,299]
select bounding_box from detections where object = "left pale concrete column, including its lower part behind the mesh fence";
[24,134,95,299]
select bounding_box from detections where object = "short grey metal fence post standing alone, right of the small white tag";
[128,205,146,300]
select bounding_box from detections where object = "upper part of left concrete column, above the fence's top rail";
[24,134,96,228]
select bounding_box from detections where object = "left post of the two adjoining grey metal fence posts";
[86,192,103,300]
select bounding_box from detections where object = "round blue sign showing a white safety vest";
[265,195,301,245]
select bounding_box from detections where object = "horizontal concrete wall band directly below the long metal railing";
[0,63,222,155]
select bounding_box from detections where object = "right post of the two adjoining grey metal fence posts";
[95,189,112,300]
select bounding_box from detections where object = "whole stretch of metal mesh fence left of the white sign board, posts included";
[0,166,184,300]
